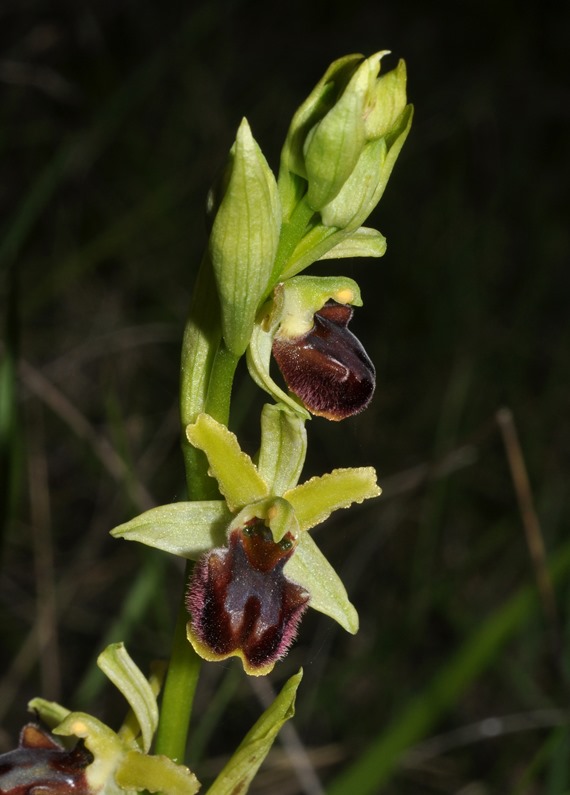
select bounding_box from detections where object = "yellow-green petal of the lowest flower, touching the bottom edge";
[115,751,200,795]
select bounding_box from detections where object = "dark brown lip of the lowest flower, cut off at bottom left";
[0,723,93,795]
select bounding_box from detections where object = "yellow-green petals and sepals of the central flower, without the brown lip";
[112,405,380,633]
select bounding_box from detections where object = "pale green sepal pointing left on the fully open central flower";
[111,500,227,560]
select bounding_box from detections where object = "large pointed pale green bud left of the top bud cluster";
[209,119,281,356]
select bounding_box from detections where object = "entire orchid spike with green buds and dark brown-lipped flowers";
[6,51,412,795]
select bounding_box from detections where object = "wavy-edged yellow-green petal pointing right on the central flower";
[283,467,382,530]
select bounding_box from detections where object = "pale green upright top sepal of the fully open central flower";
[257,404,307,495]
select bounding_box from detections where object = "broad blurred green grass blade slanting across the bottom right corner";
[327,544,570,795]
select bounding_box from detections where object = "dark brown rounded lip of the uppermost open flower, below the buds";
[273,300,376,420]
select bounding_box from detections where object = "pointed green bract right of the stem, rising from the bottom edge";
[208,670,303,795]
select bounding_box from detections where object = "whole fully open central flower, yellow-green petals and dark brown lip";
[112,405,380,675]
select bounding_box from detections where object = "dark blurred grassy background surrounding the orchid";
[0,0,570,795]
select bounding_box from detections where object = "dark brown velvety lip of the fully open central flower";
[187,519,309,675]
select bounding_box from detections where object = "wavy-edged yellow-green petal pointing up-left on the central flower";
[186,414,269,512]
